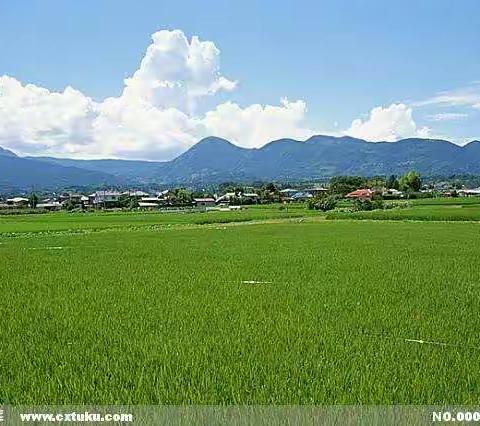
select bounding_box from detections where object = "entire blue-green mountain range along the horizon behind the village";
[0,135,480,189]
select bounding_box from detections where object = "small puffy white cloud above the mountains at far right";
[344,104,430,142]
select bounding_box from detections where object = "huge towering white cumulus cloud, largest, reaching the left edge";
[0,30,236,159]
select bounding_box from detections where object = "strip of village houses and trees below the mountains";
[0,172,480,212]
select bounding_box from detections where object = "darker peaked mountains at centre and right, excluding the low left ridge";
[150,135,480,183]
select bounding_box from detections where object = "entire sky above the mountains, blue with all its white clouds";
[0,0,480,160]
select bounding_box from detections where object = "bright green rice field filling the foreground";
[0,218,480,405]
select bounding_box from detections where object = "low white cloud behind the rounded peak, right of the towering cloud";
[203,99,314,148]
